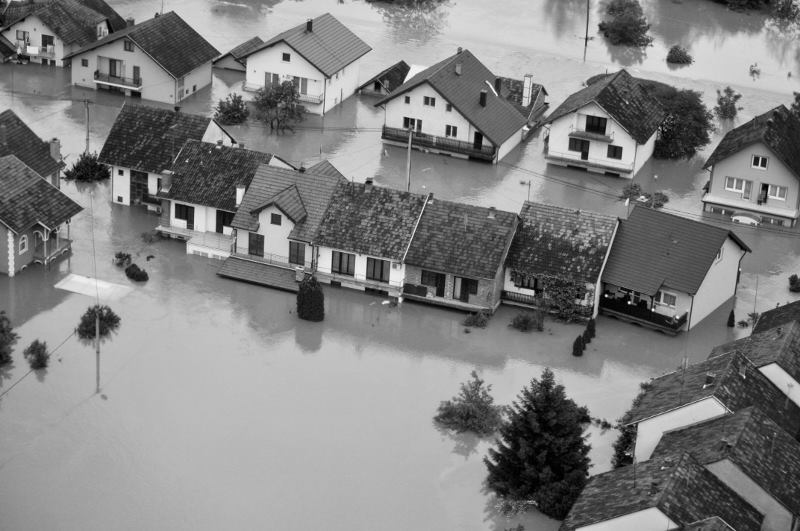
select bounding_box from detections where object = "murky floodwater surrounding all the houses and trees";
[0,0,800,530]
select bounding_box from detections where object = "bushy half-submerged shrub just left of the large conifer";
[433,371,505,437]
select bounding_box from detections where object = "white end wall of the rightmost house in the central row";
[689,238,745,328]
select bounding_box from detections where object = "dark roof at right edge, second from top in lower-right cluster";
[709,321,800,382]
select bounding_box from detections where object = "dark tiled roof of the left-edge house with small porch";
[0,155,83,234]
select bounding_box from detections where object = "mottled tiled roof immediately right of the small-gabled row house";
[318,182,426,261]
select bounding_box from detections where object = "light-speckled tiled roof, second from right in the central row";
[506,201,617,284]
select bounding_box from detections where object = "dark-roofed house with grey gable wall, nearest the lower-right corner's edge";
[653,406,800,531]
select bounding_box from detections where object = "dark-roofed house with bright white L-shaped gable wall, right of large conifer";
[627,352,800,463]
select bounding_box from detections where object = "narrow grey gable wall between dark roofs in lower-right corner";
[706,459,792,531]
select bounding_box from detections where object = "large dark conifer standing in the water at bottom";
[484,369,591,519]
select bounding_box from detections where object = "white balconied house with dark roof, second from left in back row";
[64,11,219,103]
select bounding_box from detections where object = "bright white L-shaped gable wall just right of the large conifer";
[634,397,728,463]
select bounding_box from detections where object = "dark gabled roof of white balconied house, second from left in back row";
[64,11,219,79]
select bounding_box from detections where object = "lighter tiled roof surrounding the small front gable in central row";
[231,161,346,243]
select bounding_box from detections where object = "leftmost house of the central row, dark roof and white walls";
[99,102,235,211]
